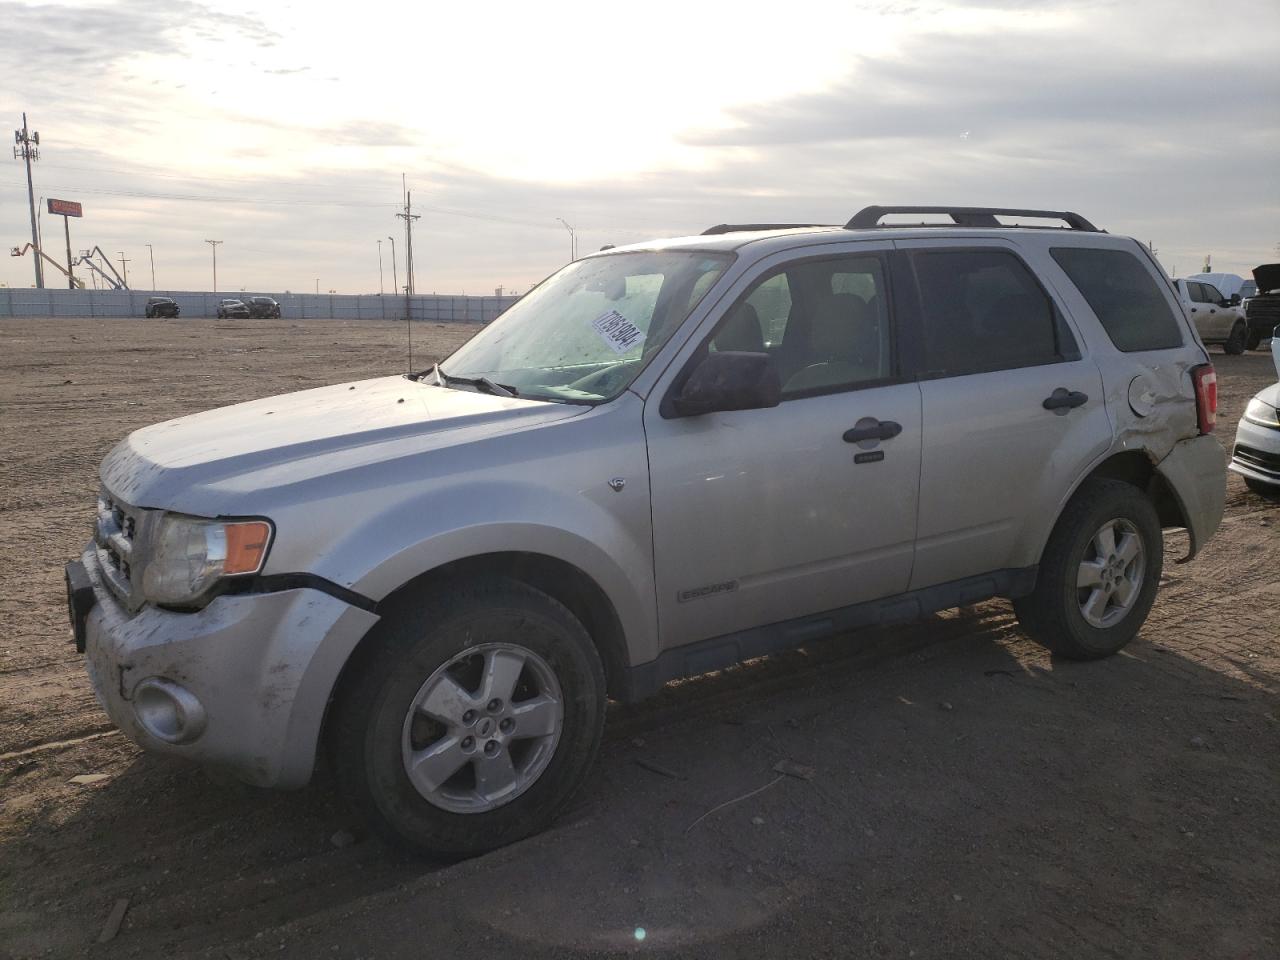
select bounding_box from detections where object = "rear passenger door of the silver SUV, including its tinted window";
[896,238,1111,589]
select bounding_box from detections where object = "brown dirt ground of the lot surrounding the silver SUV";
[0,320,1280,960]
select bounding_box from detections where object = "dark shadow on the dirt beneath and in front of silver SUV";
[0,602,1280,957]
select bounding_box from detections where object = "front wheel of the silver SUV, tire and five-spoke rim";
[329,579,607,859]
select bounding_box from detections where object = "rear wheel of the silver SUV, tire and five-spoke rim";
[1014,479,1165,660]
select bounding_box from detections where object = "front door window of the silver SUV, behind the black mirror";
[709,255,893,399]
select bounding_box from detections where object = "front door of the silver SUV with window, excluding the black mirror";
[645,243,920,648]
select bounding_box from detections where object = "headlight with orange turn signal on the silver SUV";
[142,513,271,605]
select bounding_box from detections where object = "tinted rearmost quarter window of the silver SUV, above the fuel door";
[1050,247,1177,353]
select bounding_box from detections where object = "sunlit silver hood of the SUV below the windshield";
[100,376,590,516]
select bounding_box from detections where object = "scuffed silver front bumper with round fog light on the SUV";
[67,547,378,787]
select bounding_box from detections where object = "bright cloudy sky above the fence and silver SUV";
[0,0,1280,294]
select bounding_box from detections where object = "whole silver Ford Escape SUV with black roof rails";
[67,207,1225,856]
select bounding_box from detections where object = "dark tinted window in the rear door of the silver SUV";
[911,250,1079,378]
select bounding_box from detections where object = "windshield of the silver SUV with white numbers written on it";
[440,251,732,403]
